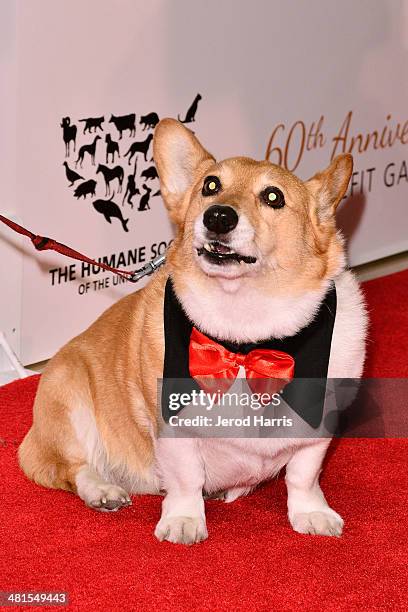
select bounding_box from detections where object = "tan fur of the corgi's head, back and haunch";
[19,119,364,540]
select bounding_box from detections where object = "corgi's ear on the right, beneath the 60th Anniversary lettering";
[306,153,353,222]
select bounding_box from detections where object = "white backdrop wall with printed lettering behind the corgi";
[0,0,408,363]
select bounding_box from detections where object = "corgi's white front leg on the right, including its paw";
[286,438,343,536]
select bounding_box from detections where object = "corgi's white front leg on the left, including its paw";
[155,438,208,544]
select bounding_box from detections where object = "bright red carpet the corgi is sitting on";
[0,271,408,612]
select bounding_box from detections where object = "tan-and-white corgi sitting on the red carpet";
[19,119,367,544]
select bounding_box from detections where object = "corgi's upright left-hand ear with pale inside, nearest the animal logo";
[153,119,215,224]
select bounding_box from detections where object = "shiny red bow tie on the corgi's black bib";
[189,327,295,396]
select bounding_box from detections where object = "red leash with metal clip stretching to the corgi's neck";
[0,215,165,283]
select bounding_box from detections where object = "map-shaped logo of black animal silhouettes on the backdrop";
[60,94,201,232]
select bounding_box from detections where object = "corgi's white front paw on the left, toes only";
[154,516,208,544]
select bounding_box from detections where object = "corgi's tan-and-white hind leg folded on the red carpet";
[18,389,131,512]
